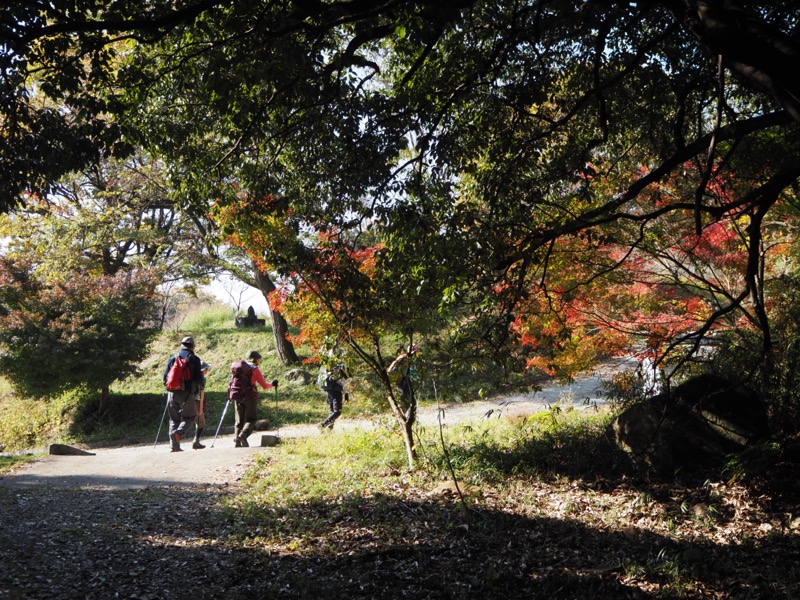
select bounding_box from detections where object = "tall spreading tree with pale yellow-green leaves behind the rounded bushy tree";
[0,152,219,324]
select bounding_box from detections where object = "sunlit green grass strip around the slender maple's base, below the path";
[231,411,615,537]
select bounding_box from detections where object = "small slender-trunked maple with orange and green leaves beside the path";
[213,193,456,468]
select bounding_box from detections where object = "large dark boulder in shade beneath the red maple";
[608,375,769,474]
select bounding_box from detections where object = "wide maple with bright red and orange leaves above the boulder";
[514,155,797,375]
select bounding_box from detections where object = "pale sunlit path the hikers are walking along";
[0,361,631,490]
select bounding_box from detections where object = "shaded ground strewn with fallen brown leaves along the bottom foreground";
[0,475,800,600]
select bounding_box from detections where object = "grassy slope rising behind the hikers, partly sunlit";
[0,306,374,452]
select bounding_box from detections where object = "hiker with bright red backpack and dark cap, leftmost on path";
[164,337,203,452]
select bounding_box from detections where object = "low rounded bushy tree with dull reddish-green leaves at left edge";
[0,259,160,397]
